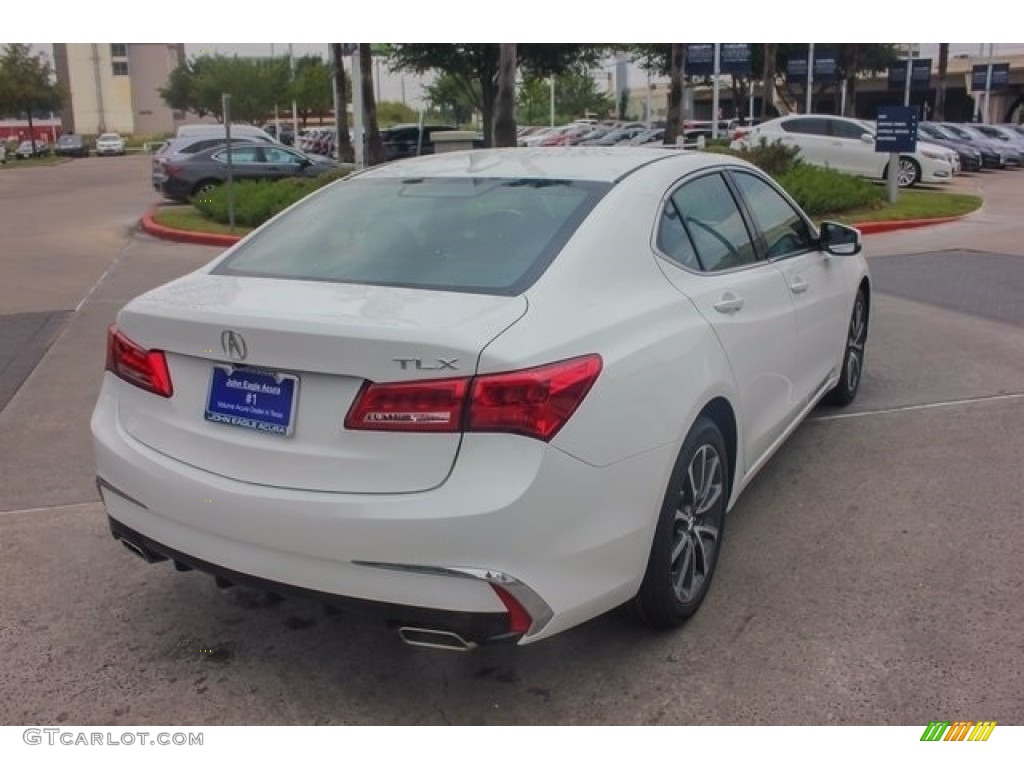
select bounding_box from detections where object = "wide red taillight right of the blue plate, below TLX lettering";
[345,354,601,441]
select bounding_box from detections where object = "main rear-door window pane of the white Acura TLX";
[672,173,757,272]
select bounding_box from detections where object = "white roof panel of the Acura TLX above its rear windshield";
[366,146,740,182]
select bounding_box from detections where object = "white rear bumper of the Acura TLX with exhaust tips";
[86,376,663,643]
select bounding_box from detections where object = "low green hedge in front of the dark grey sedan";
[193,168,350,227]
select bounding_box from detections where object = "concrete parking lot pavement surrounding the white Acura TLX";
[0,157,1024,725]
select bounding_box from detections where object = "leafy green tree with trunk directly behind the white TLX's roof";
[388,43,609,146]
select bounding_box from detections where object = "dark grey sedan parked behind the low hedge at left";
[160,141,338,202]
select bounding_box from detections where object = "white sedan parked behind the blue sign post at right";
[731,115,959,187]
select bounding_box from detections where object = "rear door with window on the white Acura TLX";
[655,172,800,472]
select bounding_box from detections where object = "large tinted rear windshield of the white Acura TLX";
[214,178,610,295]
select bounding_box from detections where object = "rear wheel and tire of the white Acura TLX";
[630,417,729,629]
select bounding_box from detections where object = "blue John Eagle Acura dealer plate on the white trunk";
[206,366,299,437]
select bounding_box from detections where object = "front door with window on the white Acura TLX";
[730,170,852,403]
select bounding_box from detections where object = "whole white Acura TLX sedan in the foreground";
[92,147,871,649]
